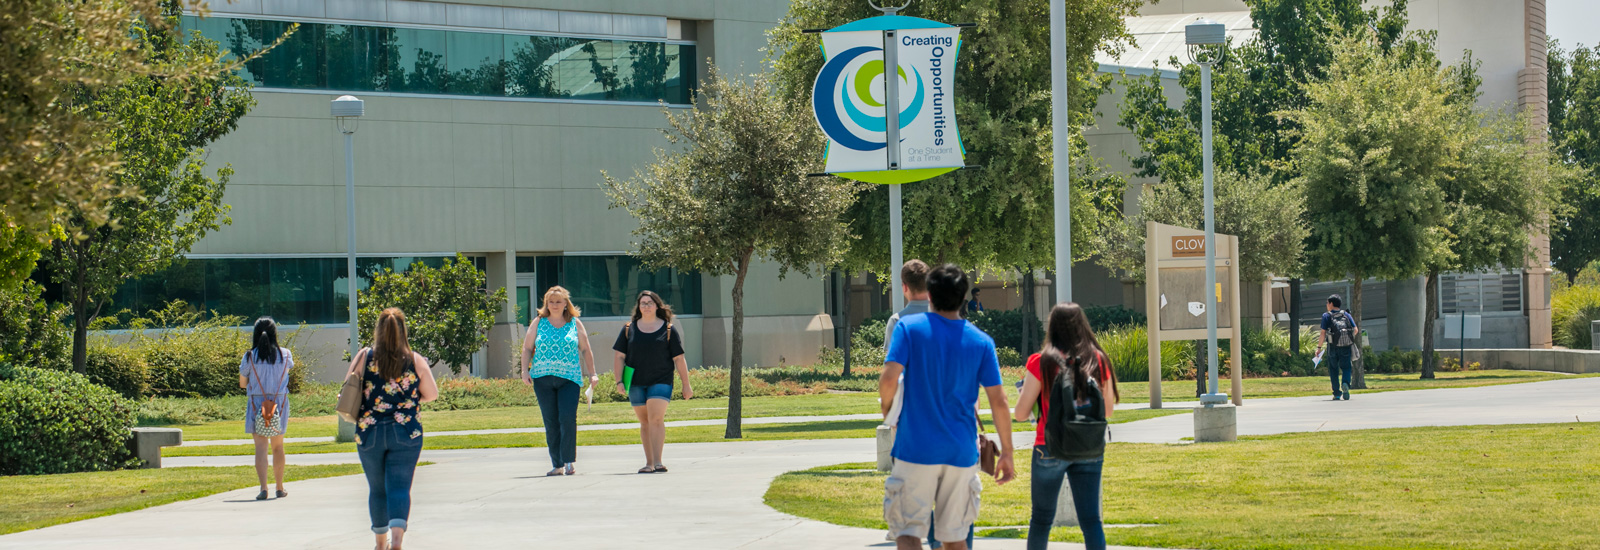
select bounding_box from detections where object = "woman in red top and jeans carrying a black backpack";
[1013,302,1117,550]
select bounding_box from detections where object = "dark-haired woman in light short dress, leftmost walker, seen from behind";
[238,317,294,500]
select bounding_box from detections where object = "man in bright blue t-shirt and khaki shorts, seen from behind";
[878,264,1016,550]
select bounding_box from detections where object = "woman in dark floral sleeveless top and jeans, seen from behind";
[350,307,438,550]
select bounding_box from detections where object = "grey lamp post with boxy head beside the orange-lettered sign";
[1184,19,1238,406]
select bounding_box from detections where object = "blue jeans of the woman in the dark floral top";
[355,422,422,534]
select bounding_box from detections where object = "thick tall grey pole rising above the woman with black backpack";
[1050,0,1075,302]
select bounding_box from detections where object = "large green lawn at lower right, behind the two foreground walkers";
[766,422,1600,550]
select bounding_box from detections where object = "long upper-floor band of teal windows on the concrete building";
[181,16,696,104]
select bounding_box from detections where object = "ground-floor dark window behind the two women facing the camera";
[534,256,701,317]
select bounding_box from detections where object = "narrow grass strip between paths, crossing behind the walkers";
[162,409,1190,457]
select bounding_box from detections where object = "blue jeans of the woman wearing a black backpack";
[1027,446,1106,550]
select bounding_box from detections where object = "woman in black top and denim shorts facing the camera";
[611,291,694,473]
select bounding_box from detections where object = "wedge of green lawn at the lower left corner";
[0,464,371,534]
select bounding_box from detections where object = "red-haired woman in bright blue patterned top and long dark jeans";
[522,286,600,475]
